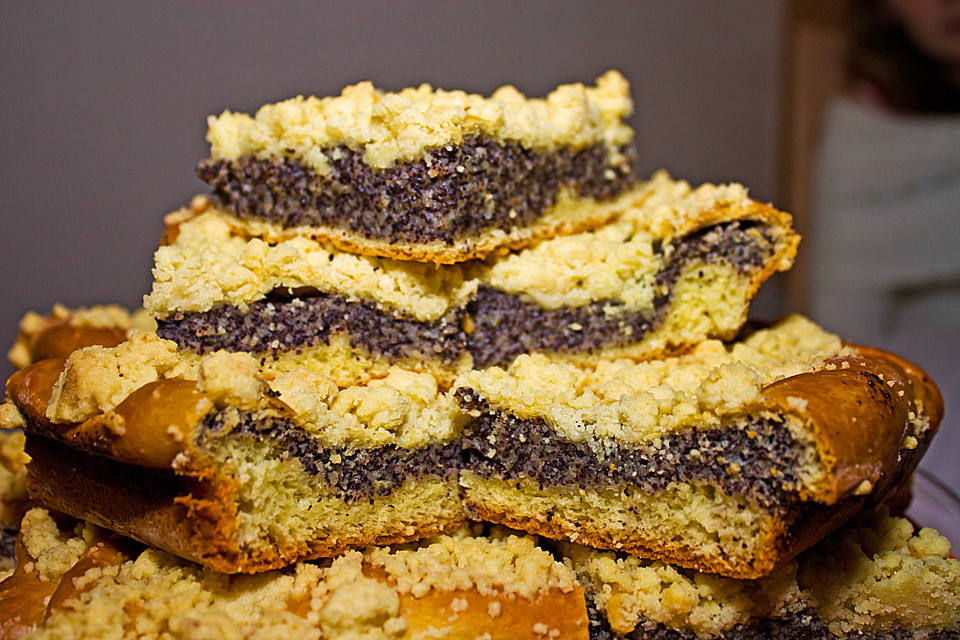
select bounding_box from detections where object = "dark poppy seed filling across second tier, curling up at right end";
[157,221,775,368]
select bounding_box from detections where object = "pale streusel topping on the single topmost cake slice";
[207,71,633,173]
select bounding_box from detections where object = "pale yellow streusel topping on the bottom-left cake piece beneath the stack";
[23,509,577,640]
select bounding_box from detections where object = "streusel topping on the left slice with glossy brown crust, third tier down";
[43,332,461,448]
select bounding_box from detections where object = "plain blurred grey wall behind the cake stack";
[0,0,783,379]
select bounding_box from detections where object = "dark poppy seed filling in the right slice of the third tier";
[456,388,803,511]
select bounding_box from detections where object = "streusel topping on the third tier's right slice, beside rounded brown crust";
[456,316,847,443]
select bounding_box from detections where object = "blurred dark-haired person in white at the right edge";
[808,0,960,493]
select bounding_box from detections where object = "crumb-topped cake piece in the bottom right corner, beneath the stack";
[561,508,960,640]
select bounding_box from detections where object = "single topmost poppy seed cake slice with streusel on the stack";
[197,71,638,264]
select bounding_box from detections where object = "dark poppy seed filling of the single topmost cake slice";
[197,137,637,245]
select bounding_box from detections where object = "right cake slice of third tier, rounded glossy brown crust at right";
[455,317,942,578]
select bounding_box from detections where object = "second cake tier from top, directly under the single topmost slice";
[145,173,798,386]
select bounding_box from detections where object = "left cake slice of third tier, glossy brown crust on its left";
[2,332,464,572]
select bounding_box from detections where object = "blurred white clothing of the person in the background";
[801,98,960,494]
